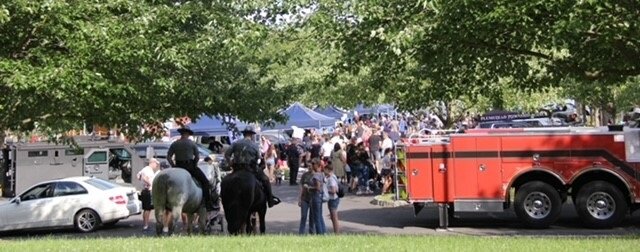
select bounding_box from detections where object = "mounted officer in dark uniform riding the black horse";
[224,125,280,207]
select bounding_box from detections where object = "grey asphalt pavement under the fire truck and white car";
[0,182,640,239]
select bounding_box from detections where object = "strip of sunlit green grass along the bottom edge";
[0,235,640,252]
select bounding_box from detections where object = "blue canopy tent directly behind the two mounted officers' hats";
[170,115,246,136]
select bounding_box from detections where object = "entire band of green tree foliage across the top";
[5,0,640,134]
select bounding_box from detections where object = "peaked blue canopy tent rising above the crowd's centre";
[262,102,337,130]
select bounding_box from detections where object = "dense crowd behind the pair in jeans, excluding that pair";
[261,113,429,192]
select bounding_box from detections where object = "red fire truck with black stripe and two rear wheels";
[396,127,640,228]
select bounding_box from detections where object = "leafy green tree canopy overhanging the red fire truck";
[309,0,640,108]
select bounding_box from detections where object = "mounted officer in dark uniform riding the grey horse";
[167,128,215,211]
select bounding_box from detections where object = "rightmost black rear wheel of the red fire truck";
[575,181,629,228]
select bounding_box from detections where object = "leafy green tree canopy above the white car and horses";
[0,0,291,138]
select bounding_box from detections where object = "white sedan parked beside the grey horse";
[0,177,142,232]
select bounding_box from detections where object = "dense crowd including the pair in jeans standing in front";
[252,116,432,234]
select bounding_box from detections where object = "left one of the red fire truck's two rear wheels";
[514,181,562,228]
